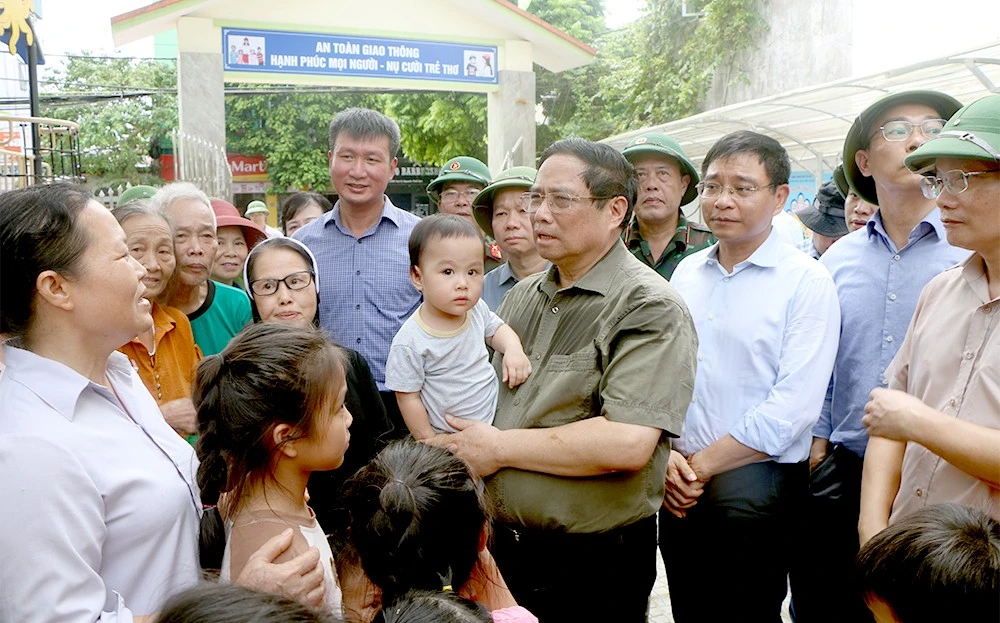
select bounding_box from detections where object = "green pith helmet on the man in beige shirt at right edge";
[903,95,1000,173]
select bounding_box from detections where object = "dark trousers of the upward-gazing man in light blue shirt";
[791,446,873,623]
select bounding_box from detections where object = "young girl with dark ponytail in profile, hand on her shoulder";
[193,324,351,614]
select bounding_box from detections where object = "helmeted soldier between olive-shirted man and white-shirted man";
[622,132,716,279]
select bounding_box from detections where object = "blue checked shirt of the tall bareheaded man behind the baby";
[292,197,421,391]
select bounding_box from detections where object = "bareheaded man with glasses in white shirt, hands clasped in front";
[661,131,840,623]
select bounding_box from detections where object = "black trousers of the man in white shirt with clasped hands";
[660,461,809,623]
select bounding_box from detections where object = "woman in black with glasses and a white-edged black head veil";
[243,238,392,532]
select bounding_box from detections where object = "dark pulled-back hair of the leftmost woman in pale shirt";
[0,183,93,337]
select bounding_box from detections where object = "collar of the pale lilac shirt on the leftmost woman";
[4,341,132,421]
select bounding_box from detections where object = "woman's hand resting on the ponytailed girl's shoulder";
[234,528,326,607]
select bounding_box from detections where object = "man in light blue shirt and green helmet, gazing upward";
[792,91,969,623]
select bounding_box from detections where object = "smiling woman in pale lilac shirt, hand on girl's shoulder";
[0,184,322,623]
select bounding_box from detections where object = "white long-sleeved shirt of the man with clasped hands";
[670,228,840,463]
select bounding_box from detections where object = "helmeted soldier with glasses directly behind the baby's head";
[427,156,503,272]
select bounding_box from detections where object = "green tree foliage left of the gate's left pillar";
[41,57,177,185]
